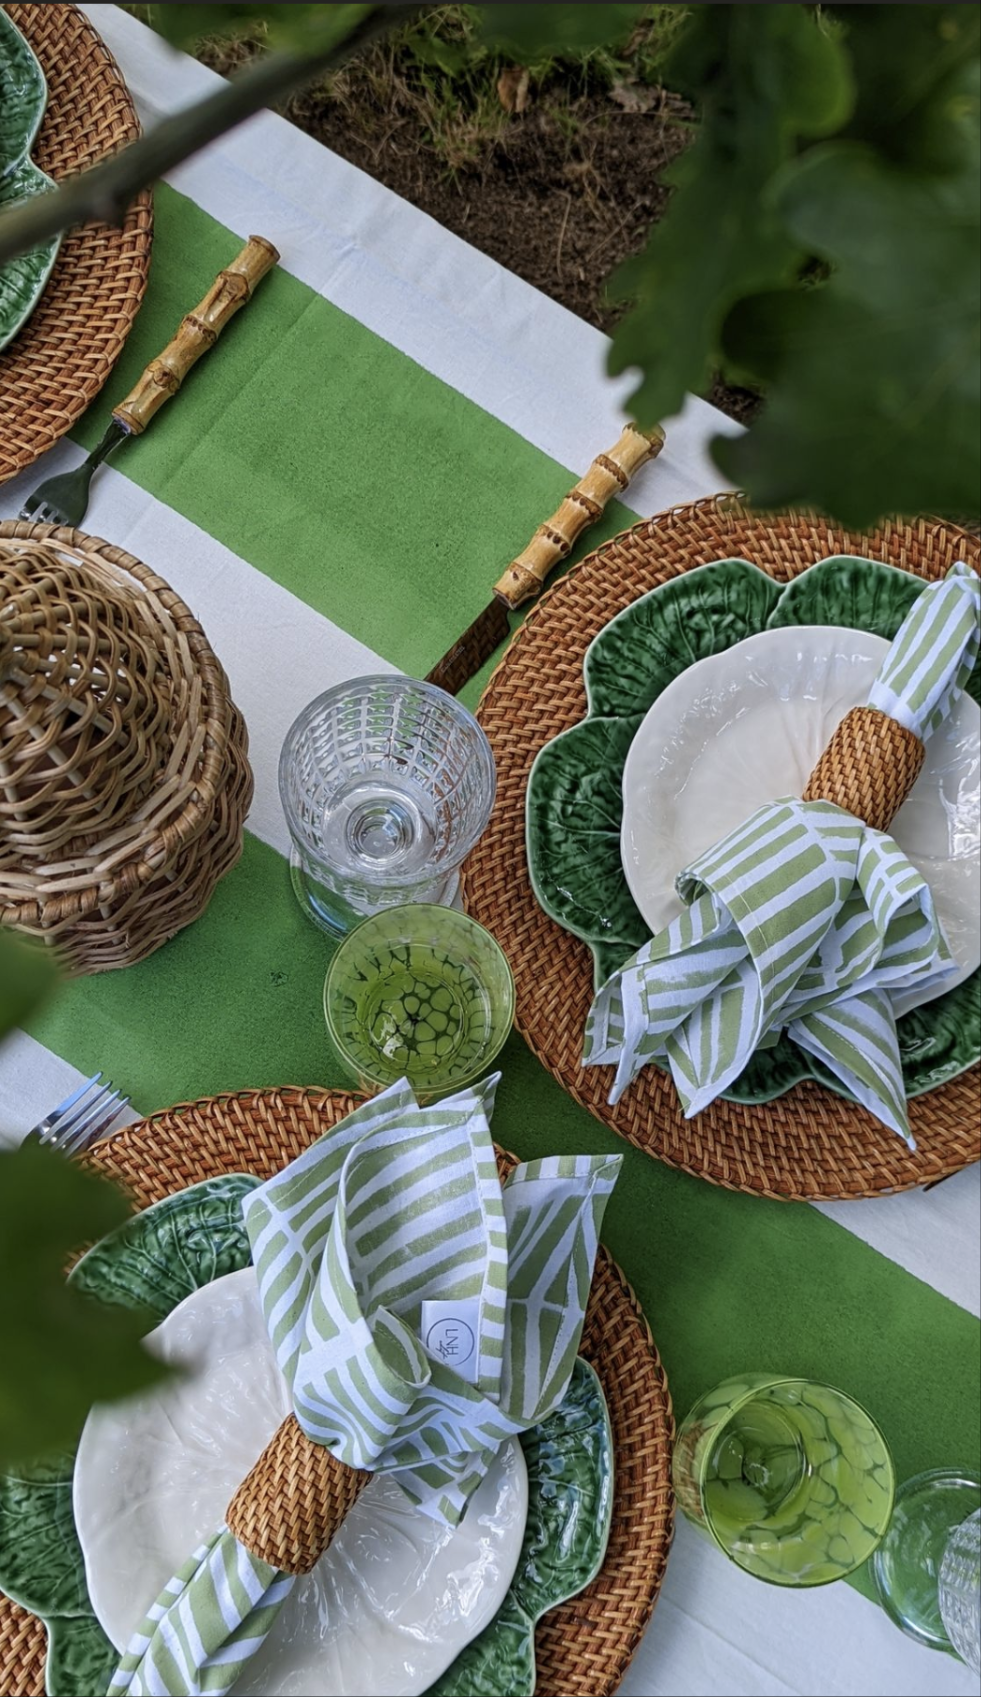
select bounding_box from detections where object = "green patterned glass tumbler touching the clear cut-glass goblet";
[324,903,514,1100]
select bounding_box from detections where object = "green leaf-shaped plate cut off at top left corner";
[0,10,61,350]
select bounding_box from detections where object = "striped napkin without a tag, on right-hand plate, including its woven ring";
[584,563,981,1147]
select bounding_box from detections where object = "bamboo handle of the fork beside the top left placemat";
[112,236,278,436]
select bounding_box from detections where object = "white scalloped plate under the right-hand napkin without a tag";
[619,624,981,1013]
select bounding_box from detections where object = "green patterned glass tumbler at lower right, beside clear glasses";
[672,1373,896,1587]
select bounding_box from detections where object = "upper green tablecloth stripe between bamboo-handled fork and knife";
[73,185,635,694]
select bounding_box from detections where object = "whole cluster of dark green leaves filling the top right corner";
[611,5,981,526]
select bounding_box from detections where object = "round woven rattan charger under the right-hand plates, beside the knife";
[463,496,981,1200]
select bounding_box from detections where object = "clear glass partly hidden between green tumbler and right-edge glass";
[872,1468,981,1655]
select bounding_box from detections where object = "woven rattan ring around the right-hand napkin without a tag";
[803,708,927,832]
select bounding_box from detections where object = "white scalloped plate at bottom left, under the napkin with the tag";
[75,1268,528,1697]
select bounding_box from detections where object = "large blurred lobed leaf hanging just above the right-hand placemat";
[713,123,981,528]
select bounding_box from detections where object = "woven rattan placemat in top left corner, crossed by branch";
[0,5,153,484]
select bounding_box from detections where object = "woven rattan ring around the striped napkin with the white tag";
[226,1414,373,1573]
